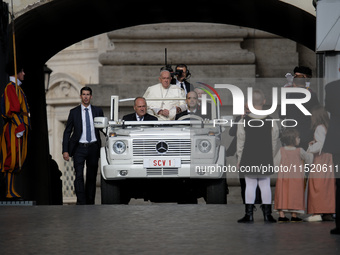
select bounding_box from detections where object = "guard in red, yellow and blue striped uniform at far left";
[0,67,30,200]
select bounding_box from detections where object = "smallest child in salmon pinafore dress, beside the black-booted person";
[274,128,313,223]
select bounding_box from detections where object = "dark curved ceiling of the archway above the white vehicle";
[11,0,316,66]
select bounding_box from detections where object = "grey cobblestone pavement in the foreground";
[0,203,340,255]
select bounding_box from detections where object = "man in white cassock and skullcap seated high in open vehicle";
[143,70,186,120]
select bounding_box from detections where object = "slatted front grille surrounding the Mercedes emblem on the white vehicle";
[132,139,191,156]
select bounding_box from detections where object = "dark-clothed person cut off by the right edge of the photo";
[322,80,340,235]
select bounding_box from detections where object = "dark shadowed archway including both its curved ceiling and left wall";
[1,0,315,204]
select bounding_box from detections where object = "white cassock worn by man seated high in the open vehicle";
[143,83,187,120]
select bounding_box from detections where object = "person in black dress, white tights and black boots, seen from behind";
[237,90,279,223]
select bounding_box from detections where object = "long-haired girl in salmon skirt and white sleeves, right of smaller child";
[305,105,335,221]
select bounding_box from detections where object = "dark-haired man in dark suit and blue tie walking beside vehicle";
[63,87,104,205]
